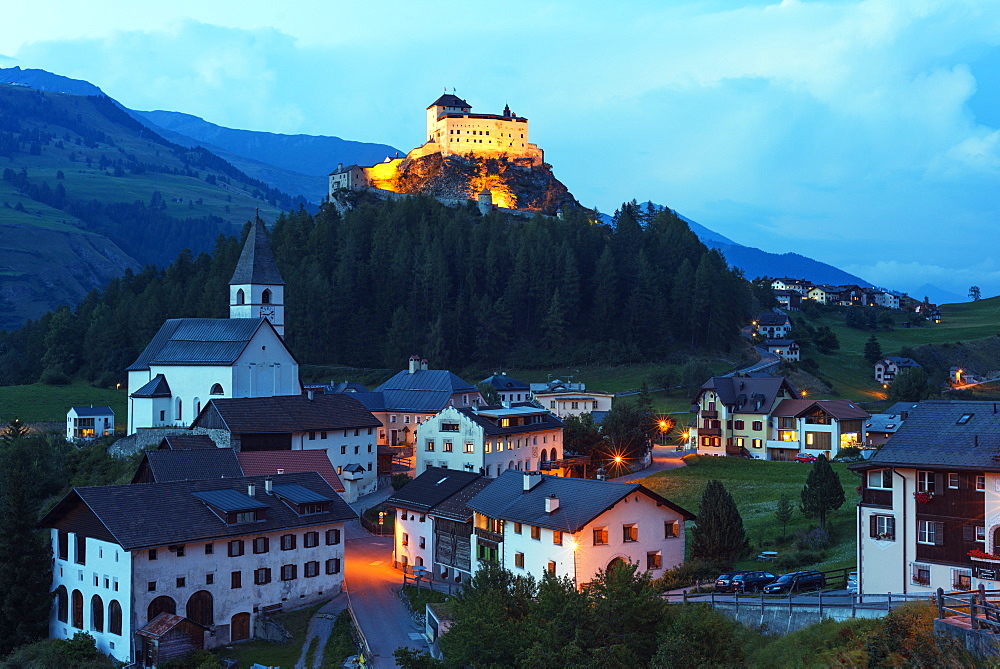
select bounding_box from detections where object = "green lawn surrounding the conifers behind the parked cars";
[642,456,859,570]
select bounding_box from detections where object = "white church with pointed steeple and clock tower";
[127,217,302,434]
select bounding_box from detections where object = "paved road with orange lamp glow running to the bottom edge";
[344,521,427,667]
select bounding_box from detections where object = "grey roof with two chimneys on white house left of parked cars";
[468,470,694,532]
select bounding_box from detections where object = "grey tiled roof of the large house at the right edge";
[864,400,1000,471]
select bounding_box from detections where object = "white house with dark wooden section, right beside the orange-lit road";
[386,467,491,583]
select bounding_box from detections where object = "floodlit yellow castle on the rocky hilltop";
[329,93,545,207]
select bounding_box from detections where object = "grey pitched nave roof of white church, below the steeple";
[128,318,273,370]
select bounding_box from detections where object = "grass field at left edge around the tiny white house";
[0,383,128,422]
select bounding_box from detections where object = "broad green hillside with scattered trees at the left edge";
[0,85,294,328]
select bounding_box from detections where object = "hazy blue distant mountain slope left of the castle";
[135,111,399,202]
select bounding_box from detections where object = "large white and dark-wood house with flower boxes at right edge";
[851,400,1000,594]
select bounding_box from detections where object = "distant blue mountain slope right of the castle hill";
[601,202,871,286]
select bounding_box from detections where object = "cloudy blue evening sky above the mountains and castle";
[0,0,1000,296]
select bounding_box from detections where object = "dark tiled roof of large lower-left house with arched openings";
[39,472,357,550]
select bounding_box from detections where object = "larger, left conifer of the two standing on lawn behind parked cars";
[691,479,750,568]
